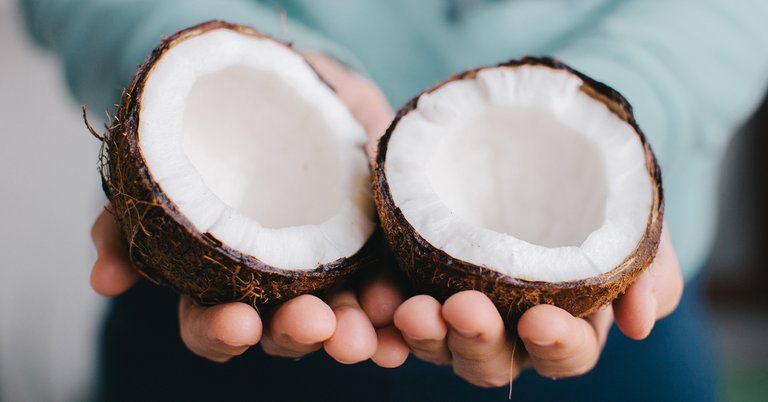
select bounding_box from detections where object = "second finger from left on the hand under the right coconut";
[442,291,512,387]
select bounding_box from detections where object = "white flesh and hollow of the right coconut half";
[385,66,652,282]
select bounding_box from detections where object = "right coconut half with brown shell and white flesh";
[374,58,664,321]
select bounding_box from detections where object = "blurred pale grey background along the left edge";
[0,0,104,402]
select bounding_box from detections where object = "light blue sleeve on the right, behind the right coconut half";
[554,0,768,279]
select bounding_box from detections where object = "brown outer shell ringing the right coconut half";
[373,57,664,324]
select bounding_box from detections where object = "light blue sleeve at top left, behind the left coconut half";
[21,0,359,110]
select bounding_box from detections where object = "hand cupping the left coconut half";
[91,55,408,367]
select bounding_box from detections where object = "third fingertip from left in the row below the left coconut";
[323,291,377,364]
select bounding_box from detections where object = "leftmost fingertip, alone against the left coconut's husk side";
[91,210,139,297]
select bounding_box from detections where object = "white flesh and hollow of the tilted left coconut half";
[139,29,375,270]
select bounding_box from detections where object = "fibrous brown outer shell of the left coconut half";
[101,21,376,306]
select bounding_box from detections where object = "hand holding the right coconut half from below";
[394,226,683,387]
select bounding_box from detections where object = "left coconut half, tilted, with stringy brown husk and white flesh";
[102,21,376,305]
